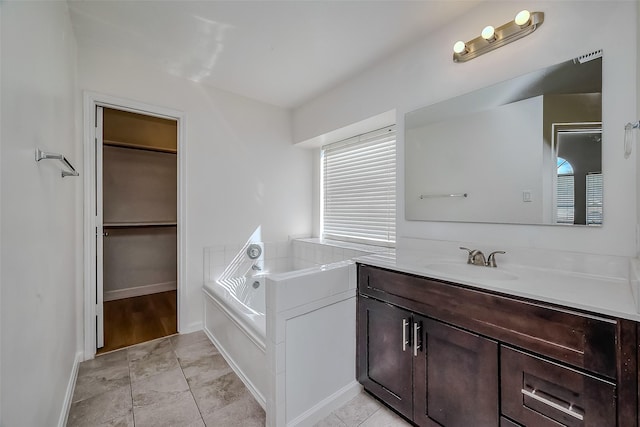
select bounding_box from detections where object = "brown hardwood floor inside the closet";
[98,291,178,354]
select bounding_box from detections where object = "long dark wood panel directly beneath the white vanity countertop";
[358,264,618,379]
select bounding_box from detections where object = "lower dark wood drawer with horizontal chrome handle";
[500,346,616,427]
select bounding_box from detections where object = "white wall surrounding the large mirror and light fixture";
[293,1,638,256]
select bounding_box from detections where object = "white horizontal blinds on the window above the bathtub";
[322,126,396,246]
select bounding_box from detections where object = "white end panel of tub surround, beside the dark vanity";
[267,261,360,427]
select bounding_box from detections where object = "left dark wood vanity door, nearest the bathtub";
[357,297,413,418]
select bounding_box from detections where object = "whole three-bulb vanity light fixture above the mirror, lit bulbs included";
[453,10,544,62]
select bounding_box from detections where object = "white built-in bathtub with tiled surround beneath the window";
[203,240,388,427]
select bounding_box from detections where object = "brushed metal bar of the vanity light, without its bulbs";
[453,12,544,62]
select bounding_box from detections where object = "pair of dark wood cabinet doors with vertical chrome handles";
[358,297,499,427]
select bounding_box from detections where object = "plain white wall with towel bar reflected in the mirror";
[405,96,551,224]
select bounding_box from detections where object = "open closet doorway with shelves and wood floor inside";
[95,106,178,353]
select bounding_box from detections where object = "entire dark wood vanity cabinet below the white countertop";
[357,262,638,427]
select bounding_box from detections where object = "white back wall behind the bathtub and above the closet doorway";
[78,48,312,331]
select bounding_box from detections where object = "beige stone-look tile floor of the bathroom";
[67,332,409,427]
